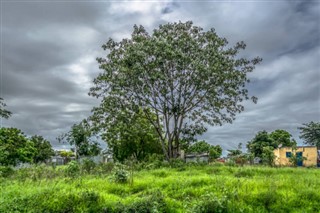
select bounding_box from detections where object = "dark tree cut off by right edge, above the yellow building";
[298,121,320,149]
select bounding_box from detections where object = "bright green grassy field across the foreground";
[0,164,320,213]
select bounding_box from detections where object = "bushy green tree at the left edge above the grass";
[0,128,35,166]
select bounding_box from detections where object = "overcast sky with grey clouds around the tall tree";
[0,0,320,152]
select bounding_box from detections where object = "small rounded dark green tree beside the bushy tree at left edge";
[30,135,54,163]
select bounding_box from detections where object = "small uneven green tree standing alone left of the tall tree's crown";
[58,120,101,158]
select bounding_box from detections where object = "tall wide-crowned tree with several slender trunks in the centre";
[89,21,261,160]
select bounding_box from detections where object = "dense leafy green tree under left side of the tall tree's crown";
[96,109,163,162]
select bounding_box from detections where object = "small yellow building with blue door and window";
[273,146,318,166]
